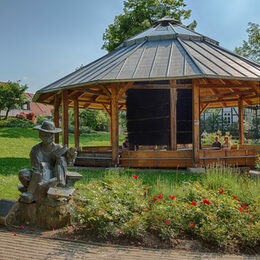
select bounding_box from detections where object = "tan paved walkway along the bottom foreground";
[0,228,260,260]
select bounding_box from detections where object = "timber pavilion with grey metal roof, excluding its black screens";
[34,18,260,167]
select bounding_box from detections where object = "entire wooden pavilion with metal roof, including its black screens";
[34,18,260,168]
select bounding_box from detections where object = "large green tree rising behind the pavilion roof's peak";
[102,0,197,52]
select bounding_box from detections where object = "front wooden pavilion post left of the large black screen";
[111,86,118,165]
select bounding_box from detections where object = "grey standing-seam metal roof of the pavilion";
[36,18,260,94]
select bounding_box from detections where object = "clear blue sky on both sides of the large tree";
[0,0,260,93]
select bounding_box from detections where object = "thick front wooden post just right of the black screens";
[192,79,200,166]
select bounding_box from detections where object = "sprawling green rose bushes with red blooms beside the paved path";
[73,169,260,247]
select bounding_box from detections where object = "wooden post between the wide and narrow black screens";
[170,88,177,150]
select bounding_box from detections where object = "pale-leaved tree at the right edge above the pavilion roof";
[235,22,260,63]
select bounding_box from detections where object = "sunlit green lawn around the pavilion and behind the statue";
[0,128,260,204]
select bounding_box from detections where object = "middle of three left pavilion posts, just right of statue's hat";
[61,89,69,146]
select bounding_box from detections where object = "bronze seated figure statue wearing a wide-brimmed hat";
[18,121,77,203]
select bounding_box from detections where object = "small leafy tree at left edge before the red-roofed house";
[0,81,28,119]
